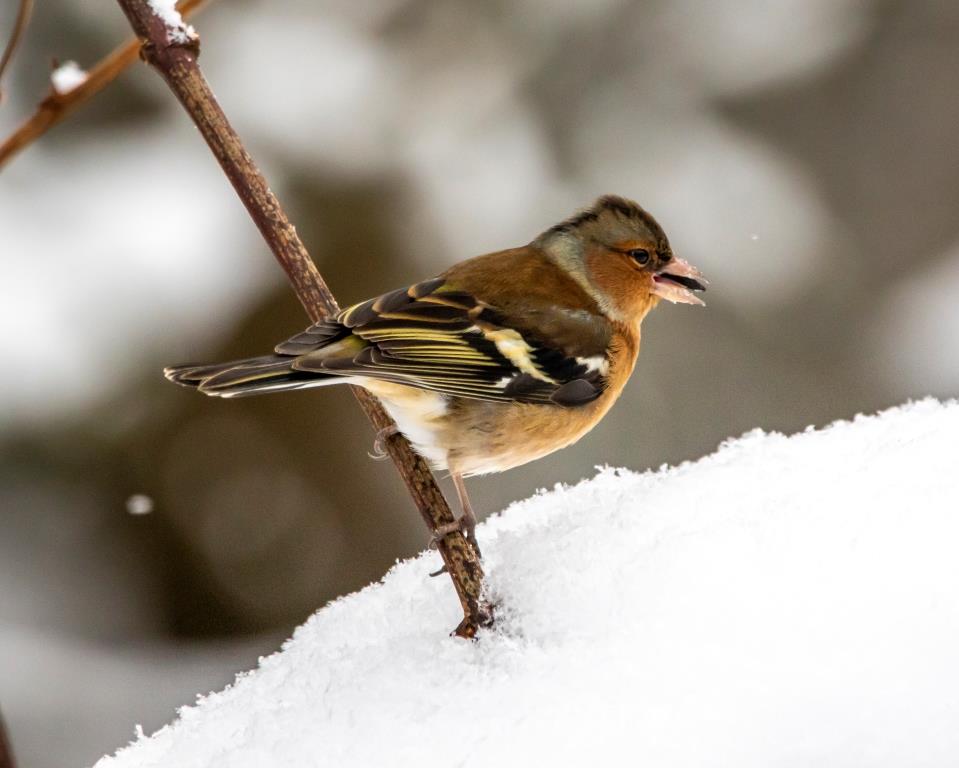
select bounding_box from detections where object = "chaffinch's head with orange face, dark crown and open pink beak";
[535,195,706,322]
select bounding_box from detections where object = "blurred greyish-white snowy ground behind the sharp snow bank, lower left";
[0,624,278,768]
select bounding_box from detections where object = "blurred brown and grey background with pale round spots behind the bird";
[0,0,959,768]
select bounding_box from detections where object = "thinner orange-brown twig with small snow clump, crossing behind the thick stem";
[0,0,205,168]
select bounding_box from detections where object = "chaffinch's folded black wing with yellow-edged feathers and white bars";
[276,278,610,407]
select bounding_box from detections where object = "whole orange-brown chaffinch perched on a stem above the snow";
[164,195,707,553]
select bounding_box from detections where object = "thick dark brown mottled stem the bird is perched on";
[118,0,492,637]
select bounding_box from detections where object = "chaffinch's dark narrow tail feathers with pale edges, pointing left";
[163,355,334,397]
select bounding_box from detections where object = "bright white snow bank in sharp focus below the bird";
[98,401,959,768]
